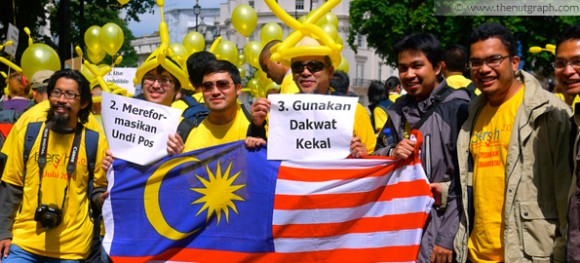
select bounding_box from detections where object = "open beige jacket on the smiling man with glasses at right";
[455,71,572,262]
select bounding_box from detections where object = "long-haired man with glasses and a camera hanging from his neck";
[0,69,107,263]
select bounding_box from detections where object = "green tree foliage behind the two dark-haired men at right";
[348,0,580,75]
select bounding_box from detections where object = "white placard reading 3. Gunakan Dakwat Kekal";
[268,94,358,160]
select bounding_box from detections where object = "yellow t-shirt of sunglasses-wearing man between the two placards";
[183,105,250,152]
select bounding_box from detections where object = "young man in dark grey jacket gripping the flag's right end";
[373,33,469,263]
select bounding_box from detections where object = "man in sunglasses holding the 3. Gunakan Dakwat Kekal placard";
[246,37,376,157]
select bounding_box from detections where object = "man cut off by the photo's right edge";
[552,25,580,262]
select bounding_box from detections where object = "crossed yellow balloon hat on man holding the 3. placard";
[264,0,343,68]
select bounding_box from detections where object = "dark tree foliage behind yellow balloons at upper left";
[0,0,155,70]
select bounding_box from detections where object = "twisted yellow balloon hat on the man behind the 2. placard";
[133,0,193,90]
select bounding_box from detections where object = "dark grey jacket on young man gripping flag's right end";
[374,82,469,262]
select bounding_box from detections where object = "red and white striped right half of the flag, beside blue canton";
[273,159,433,262]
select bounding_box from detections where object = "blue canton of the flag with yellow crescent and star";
[111,142,279,255]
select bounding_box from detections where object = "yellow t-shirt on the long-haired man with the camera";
[2,124,108,260]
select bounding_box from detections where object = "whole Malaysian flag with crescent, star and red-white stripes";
[103,141,433,262]
